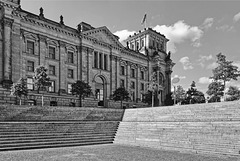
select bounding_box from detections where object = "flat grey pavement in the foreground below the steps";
[0,144,240,161]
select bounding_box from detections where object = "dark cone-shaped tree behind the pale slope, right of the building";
[183,81,205,104]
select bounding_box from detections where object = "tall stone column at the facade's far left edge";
[3,17,13,81]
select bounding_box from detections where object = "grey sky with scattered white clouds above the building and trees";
[21,0,240,92]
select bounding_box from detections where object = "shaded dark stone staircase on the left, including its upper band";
[0,106,124,151]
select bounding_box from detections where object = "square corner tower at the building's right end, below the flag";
[126,28,175,105]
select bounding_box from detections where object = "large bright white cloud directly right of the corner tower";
[153,20,203,53]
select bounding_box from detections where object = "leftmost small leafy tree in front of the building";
[11,78,28,105]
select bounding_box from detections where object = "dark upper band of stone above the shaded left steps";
[0,105,124,121]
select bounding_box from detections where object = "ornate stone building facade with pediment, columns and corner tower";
[0,0,174,107]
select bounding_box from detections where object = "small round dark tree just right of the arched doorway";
[113,87,130,108]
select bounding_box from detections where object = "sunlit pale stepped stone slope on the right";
[114,102,240,157]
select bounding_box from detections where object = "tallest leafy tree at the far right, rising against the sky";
[210,53,240,90]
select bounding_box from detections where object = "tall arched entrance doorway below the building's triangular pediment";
[95,76,105,106]
